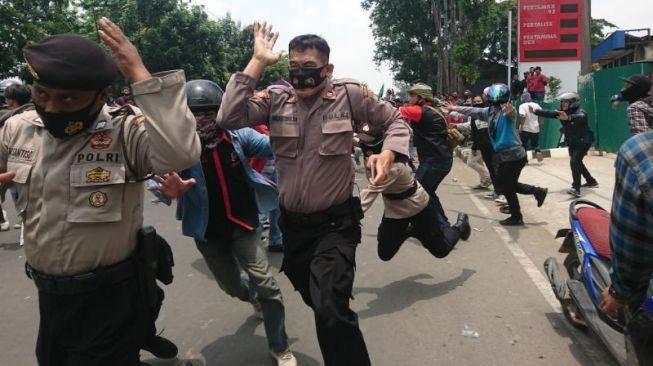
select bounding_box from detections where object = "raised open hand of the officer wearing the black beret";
[98,17,152,83]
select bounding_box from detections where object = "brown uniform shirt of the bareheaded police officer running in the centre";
[217,72,409,213]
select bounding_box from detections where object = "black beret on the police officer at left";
[23,34,118,90]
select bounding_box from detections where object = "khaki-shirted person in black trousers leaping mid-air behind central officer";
[355,133,471,261]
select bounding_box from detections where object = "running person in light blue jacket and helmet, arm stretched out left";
[446,84,548,226]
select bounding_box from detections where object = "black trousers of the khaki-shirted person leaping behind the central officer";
[377,200,460,261]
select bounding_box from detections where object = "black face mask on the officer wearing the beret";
[34,91,102,139]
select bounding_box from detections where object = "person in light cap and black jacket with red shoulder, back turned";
[399,83,453,228]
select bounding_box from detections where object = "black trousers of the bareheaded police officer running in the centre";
[281,214,371,366]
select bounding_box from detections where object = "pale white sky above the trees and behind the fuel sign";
[191,0,653,92]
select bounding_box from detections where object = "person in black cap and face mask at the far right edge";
[618,75,653,136]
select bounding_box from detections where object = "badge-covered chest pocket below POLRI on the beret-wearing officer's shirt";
[67,163,125,223]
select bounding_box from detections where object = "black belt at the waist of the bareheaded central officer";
[282,197,363,227]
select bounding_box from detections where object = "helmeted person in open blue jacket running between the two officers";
[150,80,297,366]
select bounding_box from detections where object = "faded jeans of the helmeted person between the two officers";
[195,228,288,352]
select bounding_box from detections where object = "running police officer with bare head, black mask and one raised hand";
[217,23,409,366]
